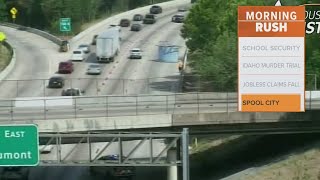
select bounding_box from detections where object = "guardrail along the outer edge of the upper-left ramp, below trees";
[0,22,62,46]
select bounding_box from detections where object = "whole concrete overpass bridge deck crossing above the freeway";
[0,91,320,132]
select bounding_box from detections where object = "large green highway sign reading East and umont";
[0,124,40,166]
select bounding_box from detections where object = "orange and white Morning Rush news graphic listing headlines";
[238,6,306,112]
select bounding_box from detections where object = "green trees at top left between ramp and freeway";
[0,0,168,34]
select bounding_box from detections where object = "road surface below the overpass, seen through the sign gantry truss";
[0,139,170,180]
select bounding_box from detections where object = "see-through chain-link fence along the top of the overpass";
[0,75,317,99]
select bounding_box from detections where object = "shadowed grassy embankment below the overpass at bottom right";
[190,134,320,180]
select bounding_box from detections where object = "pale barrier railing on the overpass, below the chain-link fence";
[0,91,320,121]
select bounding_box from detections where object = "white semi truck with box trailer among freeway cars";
[96,26,121,62]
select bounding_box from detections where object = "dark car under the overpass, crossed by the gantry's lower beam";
[90,155,136,179]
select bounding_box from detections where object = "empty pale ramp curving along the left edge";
[0,26,65,98]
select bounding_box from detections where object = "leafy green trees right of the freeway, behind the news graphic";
[182,0,320,92]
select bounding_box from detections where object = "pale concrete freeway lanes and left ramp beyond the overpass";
[0,0,187,98]
